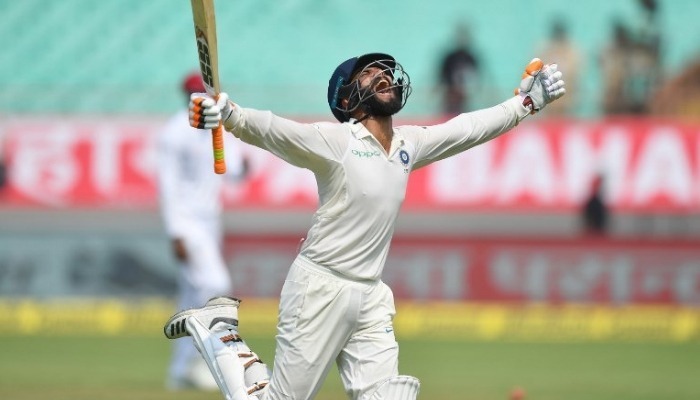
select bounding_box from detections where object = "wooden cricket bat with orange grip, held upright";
[191,0,226,174]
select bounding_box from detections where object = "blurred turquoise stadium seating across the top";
[0,0,700,116]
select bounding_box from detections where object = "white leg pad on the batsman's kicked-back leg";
[186,316,249,400]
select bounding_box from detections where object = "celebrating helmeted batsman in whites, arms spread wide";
[164,53,565,400]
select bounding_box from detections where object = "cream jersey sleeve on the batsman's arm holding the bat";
[226,106,349,171]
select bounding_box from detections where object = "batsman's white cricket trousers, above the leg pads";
[265,256,399,400]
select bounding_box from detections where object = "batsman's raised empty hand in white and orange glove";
[515,58,566,114]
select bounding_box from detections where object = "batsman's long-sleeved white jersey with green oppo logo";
[227,97,530,280]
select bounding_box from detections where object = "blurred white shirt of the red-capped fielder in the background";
[156,109,242,237]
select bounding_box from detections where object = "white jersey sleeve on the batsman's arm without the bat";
[411,96,530,170]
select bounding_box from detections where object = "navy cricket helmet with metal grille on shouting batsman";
[328,53,411,122]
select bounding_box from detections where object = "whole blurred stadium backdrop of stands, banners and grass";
[0,0,700,400]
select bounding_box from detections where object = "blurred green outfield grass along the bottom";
[0,333,700,400]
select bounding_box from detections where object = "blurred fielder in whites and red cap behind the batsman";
[157,73,243,390]
